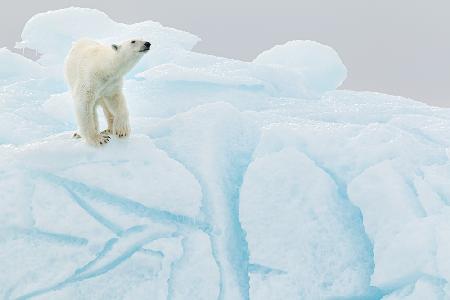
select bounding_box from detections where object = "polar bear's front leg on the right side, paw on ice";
[105,92,131,137]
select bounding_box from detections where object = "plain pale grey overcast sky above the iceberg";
[0,0,450,106]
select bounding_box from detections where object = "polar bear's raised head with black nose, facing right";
[111,39,151,74]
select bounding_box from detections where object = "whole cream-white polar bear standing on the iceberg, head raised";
[64,39,150,146]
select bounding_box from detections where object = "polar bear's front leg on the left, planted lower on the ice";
[75,95,110,146]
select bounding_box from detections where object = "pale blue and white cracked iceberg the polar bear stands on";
[0,8,450,300]
